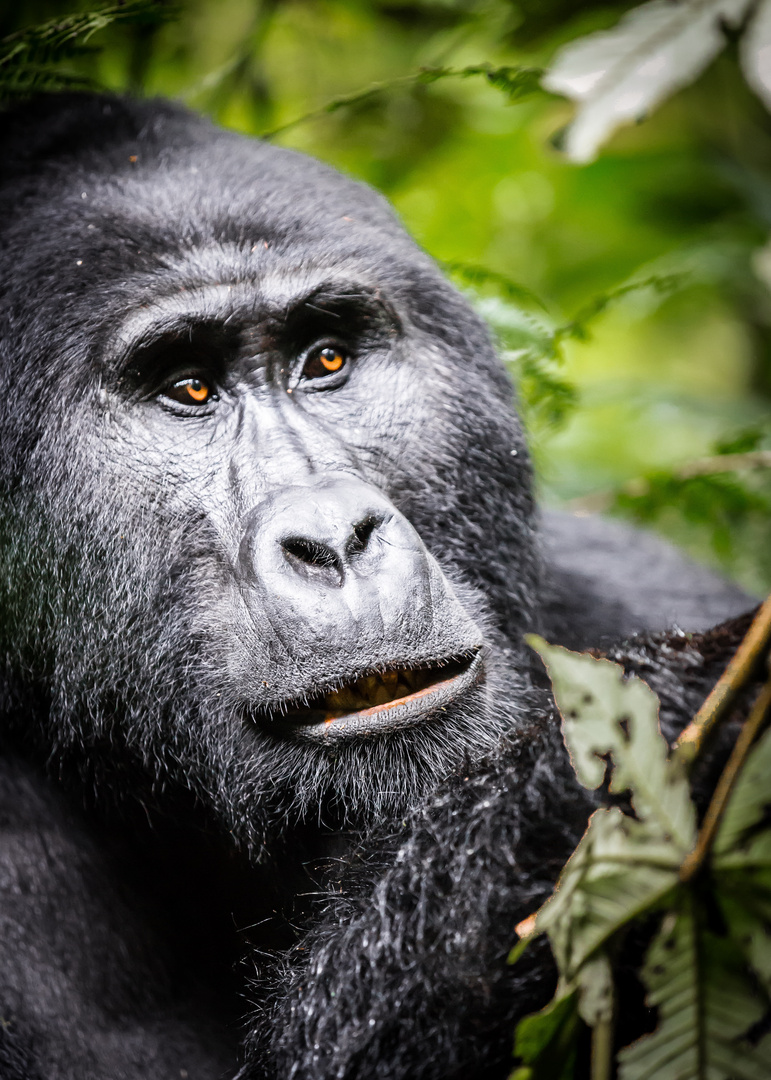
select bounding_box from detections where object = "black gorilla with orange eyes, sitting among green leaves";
[0,94,747,1080]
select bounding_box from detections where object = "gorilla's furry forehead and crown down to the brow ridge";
[0,95,501,408]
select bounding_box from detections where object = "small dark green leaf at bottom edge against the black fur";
[510,990,580,1080]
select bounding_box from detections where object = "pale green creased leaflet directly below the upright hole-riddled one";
[536,807,682,983]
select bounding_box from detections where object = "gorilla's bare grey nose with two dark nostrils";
[239,477,459,660]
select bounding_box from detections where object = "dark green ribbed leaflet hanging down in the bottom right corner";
[619,893,771,1080]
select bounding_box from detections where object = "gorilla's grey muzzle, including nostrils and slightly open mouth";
[239,477,483,735]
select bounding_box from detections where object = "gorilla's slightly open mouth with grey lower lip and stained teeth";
[264,649,483,738]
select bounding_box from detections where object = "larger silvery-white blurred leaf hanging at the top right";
[543,0,750,162]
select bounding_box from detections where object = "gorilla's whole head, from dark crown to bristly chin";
[0,96,535,847]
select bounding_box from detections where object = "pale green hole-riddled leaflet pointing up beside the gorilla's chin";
[527,635,695,855]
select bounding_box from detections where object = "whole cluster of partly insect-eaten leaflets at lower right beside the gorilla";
[509,638,771,1080]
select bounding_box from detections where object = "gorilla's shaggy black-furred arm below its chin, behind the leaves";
[251,617,757,1080]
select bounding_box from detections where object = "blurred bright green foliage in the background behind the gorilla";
[0,0,771,592]
